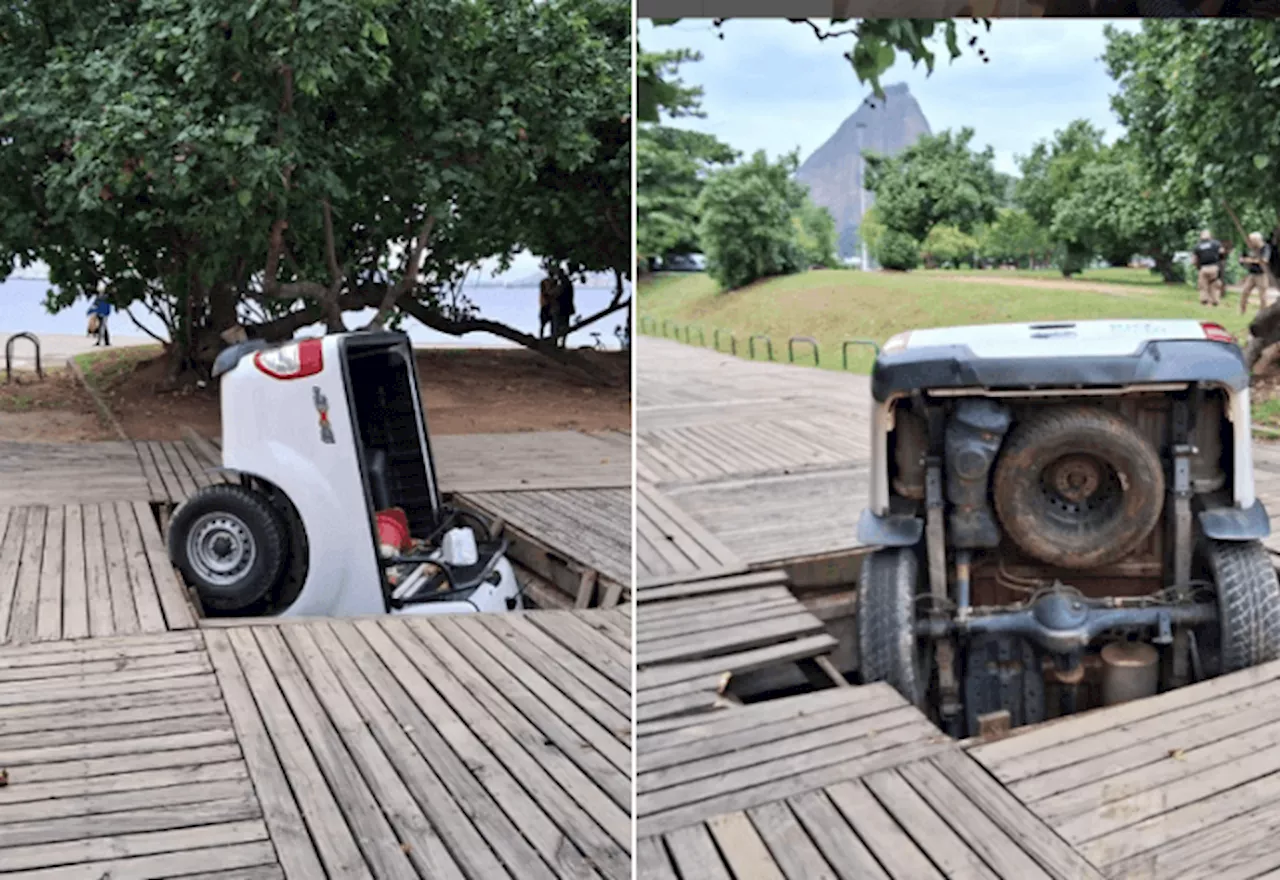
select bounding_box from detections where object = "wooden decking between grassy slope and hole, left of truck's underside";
[636,338,870,583]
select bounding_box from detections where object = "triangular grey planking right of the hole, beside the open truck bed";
[454,489,631,604]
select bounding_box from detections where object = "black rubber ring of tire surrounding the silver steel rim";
[169,483,288,611]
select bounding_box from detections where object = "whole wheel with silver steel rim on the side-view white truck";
[169,485,288,613]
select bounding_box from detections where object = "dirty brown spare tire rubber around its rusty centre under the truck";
[991,405,1165,570]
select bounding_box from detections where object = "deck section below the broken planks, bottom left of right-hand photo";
[636,684,1102,880]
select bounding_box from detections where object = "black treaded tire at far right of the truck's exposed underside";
[1206,541,1280,673]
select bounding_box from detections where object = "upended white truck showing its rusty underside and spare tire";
[858,321,1280,737]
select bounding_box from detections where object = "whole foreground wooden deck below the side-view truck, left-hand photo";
[0,611,631,880]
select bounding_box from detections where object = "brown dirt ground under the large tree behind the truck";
[0,349,631,443]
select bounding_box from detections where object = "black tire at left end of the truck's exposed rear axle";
[856,549,928,707]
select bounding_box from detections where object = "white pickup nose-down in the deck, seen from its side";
[169,331,522,617]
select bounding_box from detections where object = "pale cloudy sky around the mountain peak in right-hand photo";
[639,18,1137,173]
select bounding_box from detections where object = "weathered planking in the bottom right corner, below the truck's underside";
[969,663,1280,880]
